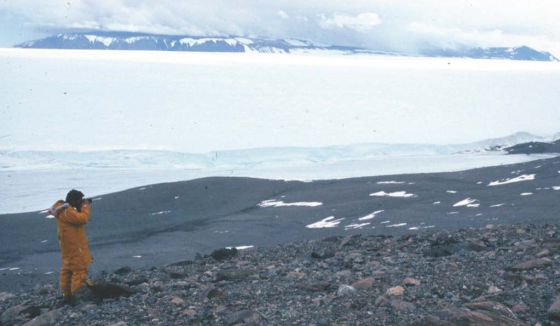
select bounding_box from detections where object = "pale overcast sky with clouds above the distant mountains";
[0,0,560,56]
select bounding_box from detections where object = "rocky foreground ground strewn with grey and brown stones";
[0,225,560,326]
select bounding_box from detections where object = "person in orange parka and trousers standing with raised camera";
[50,189,93,303]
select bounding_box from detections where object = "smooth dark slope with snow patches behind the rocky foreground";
[0,157,560,291]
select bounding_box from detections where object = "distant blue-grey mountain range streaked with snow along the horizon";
[16,32,558,61]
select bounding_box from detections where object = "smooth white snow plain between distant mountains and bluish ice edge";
[0,49,560,153]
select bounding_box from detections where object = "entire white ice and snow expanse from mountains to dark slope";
[0,49,560,214]
